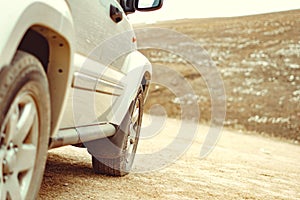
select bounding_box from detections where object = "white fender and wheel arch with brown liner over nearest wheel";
[0,0,74,138]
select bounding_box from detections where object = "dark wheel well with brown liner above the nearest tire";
[18,25,71,138]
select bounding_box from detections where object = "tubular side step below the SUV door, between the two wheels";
[49,124,116,149]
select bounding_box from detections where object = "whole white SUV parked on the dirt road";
[0,0,162,200]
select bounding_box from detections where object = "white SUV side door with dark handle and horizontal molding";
[60,0,136,129]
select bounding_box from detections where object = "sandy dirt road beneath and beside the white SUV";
[39,116,300,199]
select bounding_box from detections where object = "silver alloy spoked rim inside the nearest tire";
[0,91,39,199]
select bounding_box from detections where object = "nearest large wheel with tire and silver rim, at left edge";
[0,51,50,200]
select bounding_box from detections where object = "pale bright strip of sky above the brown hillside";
[129,0,300,23]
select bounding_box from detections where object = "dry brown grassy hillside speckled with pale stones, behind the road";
[137,10,300,143]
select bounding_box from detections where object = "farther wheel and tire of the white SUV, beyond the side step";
[87,88,144,176]
